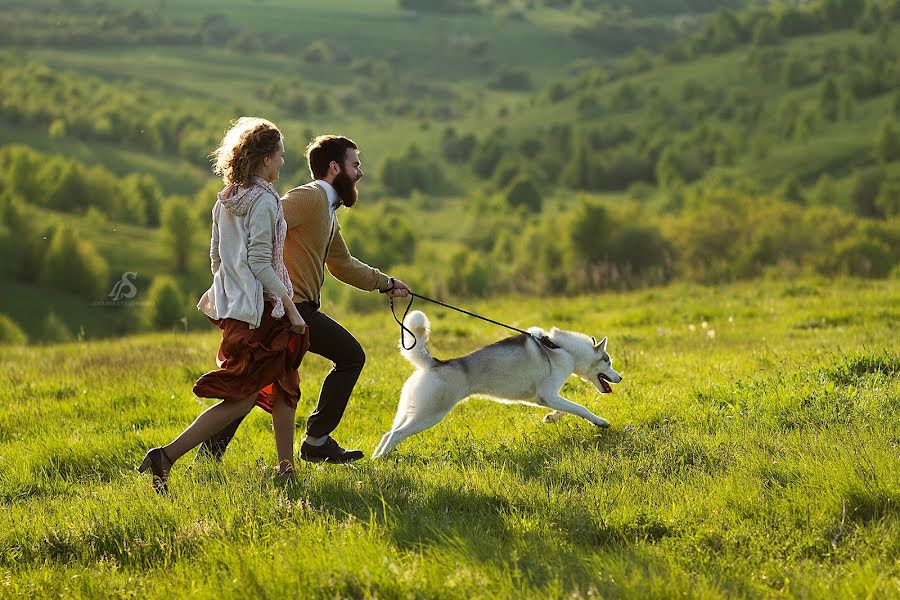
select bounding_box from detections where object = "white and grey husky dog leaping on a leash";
[372,310,622,458]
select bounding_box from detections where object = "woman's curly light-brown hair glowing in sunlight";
[210,117,282,187]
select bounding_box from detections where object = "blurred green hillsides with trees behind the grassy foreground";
[0,0,900,342]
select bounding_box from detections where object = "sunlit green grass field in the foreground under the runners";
[0,280,900,598]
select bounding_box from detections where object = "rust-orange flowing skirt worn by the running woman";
[194,302,309,412]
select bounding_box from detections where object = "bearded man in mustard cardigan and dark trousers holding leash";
[199,135,412,463]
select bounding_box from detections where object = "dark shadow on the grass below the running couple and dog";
[286,432,676,586]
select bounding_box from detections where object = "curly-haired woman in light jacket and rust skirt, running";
[139,117,309,492]
